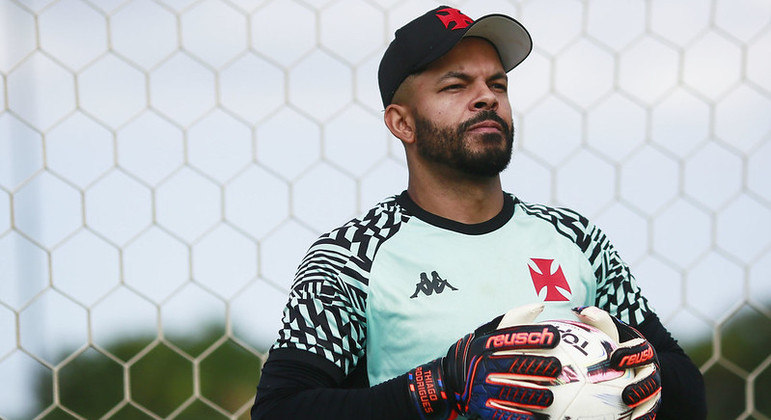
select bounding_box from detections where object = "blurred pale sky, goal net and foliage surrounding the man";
[0,0,771,419]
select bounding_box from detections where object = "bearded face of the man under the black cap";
[402,38,514,177]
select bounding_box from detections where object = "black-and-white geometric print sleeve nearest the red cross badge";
[523,199,651,326]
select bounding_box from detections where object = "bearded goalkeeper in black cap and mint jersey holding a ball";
[252,6,706,420]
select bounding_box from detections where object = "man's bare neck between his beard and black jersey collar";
[407,169,503,224]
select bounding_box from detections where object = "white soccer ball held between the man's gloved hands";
[499,320,635,420]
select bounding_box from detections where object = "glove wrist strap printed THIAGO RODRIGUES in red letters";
[407,358,454,420]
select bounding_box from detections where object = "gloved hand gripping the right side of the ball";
[573,306,661,420]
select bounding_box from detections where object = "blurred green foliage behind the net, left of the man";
[36,327,262,420]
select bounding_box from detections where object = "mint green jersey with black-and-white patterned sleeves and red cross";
[273,192,651,385]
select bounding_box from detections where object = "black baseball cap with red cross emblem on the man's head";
[378,6,533,107]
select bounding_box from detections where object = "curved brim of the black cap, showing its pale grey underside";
[463,14,533,71]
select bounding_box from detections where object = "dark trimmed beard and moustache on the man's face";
[415,111,514,178]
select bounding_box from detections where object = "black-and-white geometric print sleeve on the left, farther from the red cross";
[273,199,402,375]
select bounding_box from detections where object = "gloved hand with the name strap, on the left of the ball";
[409,304,562,420]
